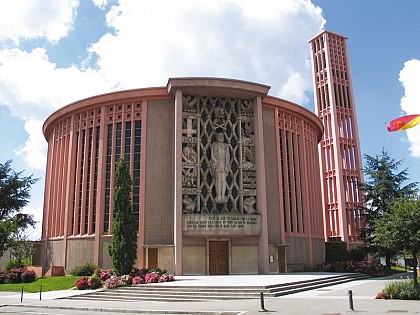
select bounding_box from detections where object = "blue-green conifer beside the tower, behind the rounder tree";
[359,148,417,268]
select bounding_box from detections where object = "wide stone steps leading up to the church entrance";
[66,274,368,302]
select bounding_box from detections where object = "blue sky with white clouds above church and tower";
[0,0,420,240]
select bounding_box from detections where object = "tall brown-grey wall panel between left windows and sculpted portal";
[144,100,174,245]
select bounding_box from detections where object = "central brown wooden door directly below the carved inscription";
[209,241,229,275]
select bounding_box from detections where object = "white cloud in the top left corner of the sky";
[0,0,79,44]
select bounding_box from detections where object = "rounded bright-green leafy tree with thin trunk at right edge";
[375,199,420,286]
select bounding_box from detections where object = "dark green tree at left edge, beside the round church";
[0,160,38,257]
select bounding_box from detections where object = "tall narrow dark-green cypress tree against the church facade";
[108,157,137,275]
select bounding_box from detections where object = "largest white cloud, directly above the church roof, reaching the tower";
[90,0,325,102]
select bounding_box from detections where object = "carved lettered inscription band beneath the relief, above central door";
[183,214,260,232]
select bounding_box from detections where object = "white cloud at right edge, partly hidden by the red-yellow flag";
[399,59,420,157]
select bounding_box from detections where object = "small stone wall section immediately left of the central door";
[182,245,207,275]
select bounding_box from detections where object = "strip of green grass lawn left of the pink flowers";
[0,276,81,293]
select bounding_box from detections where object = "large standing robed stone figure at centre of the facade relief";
[211,132,230,204]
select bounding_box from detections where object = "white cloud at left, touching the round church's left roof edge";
[0,48,111,169]
